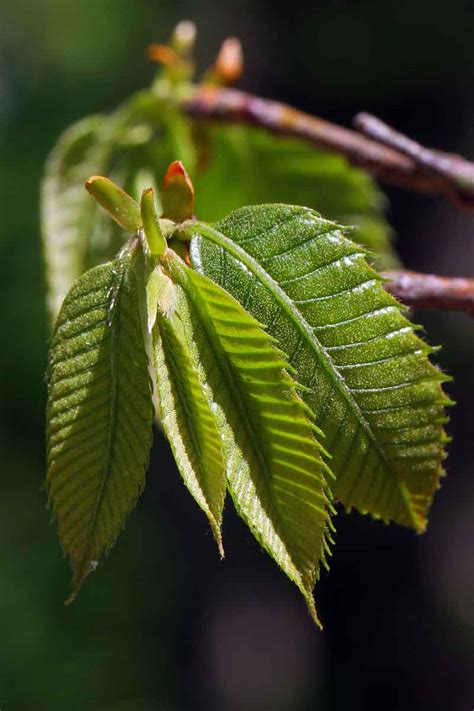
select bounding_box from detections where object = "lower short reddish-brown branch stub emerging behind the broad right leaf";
[383,271,474,316]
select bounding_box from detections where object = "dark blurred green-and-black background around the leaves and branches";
[0,0,474,711]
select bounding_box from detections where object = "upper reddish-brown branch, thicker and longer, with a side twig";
[183,86,474,210]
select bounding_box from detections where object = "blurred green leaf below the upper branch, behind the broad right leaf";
[191,125,399,269]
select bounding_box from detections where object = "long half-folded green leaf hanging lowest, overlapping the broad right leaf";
[163,250,330,624]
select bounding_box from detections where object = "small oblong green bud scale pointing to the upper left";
[86,175,142,234]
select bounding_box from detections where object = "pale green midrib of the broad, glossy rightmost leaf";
[185,221,418,527]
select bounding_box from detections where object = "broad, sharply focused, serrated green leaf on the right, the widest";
[185,205,449,531]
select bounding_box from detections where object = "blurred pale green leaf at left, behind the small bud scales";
[41,90,195,324]
